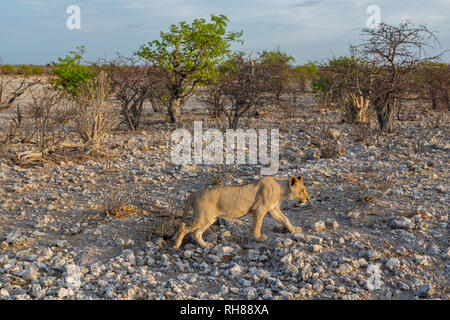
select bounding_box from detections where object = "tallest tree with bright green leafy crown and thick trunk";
[136,15,242,123]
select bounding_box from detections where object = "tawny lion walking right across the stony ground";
[174,176,309,249]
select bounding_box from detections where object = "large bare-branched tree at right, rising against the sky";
[350,21,442,133]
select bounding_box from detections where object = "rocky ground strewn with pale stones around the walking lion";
[0,92,450,299]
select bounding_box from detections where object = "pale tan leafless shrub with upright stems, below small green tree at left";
[74,71,120,148]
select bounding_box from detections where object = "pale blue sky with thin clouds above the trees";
[0,0,450,64]
